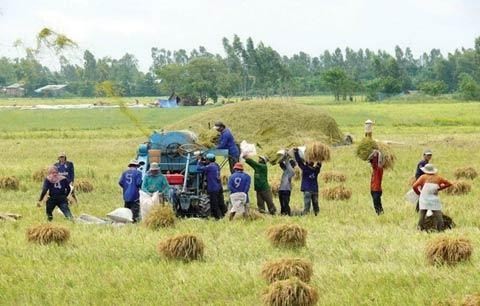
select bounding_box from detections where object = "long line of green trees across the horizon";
[0,35,480,104]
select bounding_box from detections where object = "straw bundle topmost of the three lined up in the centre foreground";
[267,224,307,248]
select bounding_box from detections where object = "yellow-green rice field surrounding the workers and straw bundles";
[0,97,480,305]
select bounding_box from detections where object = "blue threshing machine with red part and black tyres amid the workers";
[137,131,228,217]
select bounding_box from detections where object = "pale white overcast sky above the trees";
[0,0,480,71]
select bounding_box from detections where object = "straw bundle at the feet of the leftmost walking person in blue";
[27,223,70,245]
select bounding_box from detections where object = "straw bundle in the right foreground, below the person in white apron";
[425,236,473,265]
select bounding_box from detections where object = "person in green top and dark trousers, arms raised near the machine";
[244,156,277,215]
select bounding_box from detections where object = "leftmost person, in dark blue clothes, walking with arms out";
[37,166,73,221]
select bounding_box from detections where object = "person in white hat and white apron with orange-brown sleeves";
[412,164,452,231]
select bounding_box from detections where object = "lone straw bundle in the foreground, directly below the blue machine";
[157,234,204,261]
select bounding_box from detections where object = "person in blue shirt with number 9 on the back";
[228,163,251,220]
